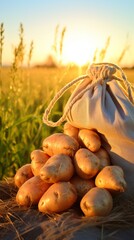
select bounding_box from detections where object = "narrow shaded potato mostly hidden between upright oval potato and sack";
[94,147,111,170]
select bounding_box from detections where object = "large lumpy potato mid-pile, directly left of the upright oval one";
[40,154,74,183]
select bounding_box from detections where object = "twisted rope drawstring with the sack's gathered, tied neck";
[43,63,134,127]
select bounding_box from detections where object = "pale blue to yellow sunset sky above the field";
[0,0,134,66]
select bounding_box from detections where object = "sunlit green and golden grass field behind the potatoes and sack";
[0,66,134,179]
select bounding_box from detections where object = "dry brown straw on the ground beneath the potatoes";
[0,180,134,240]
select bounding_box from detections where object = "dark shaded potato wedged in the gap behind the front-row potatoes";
[70,175,95,200]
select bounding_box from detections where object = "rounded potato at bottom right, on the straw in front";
[80,187,113,217]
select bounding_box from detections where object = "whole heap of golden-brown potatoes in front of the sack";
[14,122,126,216]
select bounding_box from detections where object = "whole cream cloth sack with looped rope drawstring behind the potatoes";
[43,63,134,197]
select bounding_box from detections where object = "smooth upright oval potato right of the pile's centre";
[74,148,100,179]
